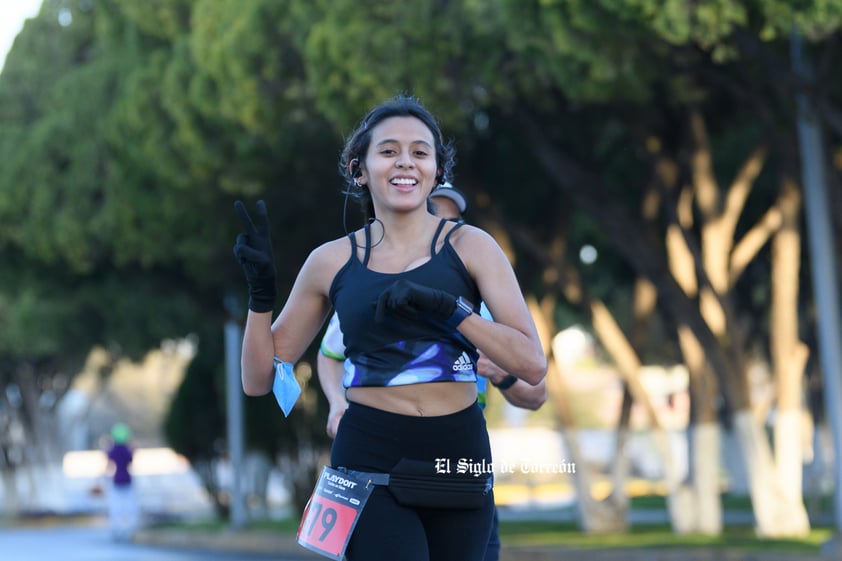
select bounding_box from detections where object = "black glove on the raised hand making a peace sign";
[234,200,278,312]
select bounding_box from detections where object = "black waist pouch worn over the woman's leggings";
[338,458,492,510]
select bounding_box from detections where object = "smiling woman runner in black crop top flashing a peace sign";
[234,95,547,561]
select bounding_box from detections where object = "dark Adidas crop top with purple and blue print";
[330,220,480,388]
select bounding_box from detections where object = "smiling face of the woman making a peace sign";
[360,117,437,214]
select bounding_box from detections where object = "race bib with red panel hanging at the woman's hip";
[296,466,374,561]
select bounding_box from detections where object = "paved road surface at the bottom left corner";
[0,526,312,561]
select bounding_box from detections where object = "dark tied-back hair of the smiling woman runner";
[339,94,456,219]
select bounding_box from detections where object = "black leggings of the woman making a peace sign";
[331,403,494,561]
